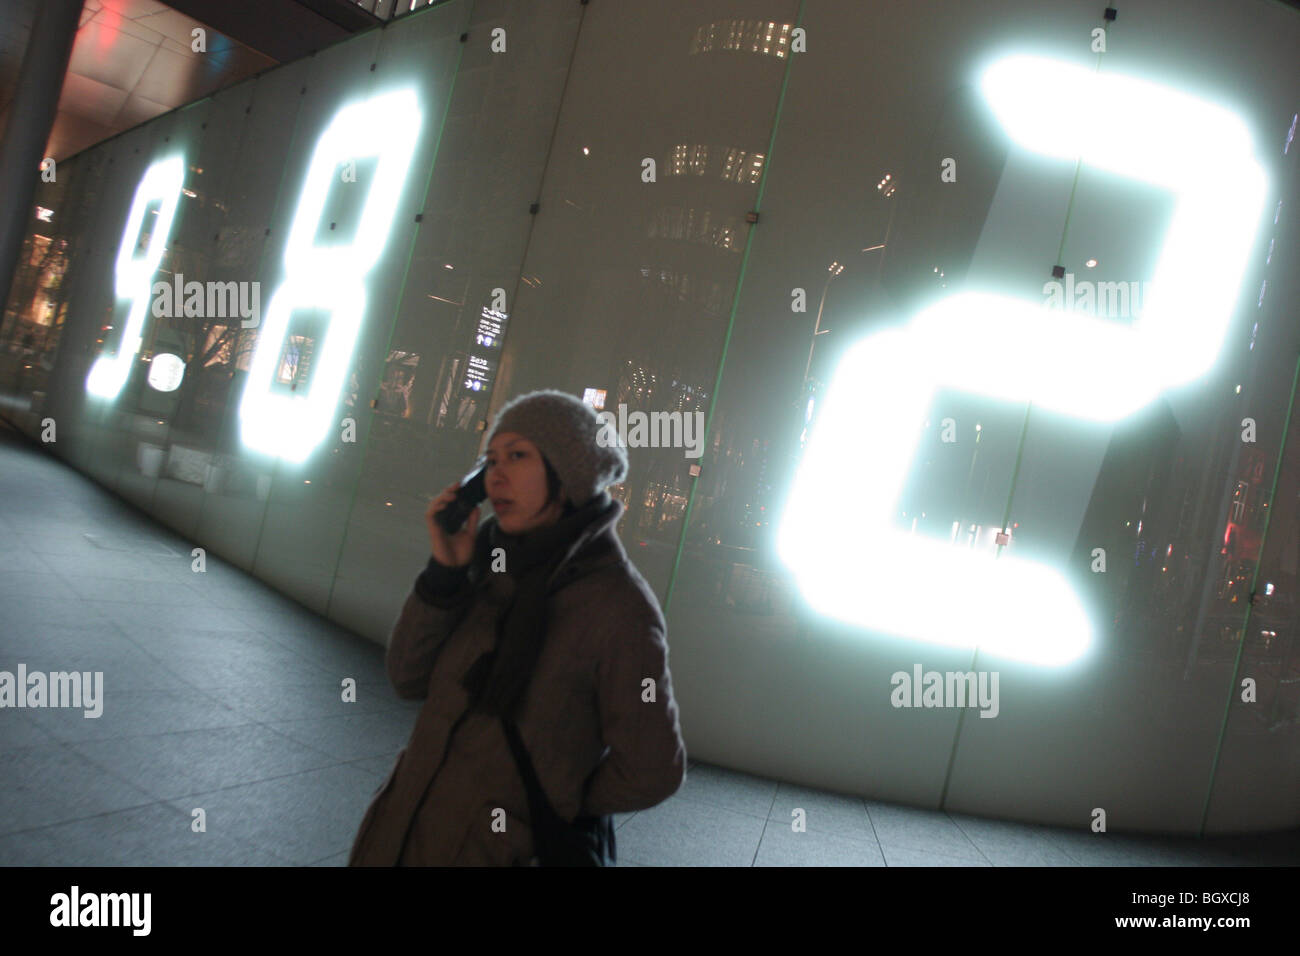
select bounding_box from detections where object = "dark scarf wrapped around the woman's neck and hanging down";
[462,492,619,719]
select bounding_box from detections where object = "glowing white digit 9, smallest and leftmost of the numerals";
[86,155,185,398]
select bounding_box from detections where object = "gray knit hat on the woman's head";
[488,389,628,507]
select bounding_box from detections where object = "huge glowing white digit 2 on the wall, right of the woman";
[777,56,1268,665]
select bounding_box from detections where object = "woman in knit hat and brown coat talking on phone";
[348,390,686,866]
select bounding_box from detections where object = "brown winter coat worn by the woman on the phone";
[348,505,686,866]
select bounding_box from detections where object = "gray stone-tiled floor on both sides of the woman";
[0,421,1300,866]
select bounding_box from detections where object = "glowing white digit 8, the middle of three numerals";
[239,90,424,462]
